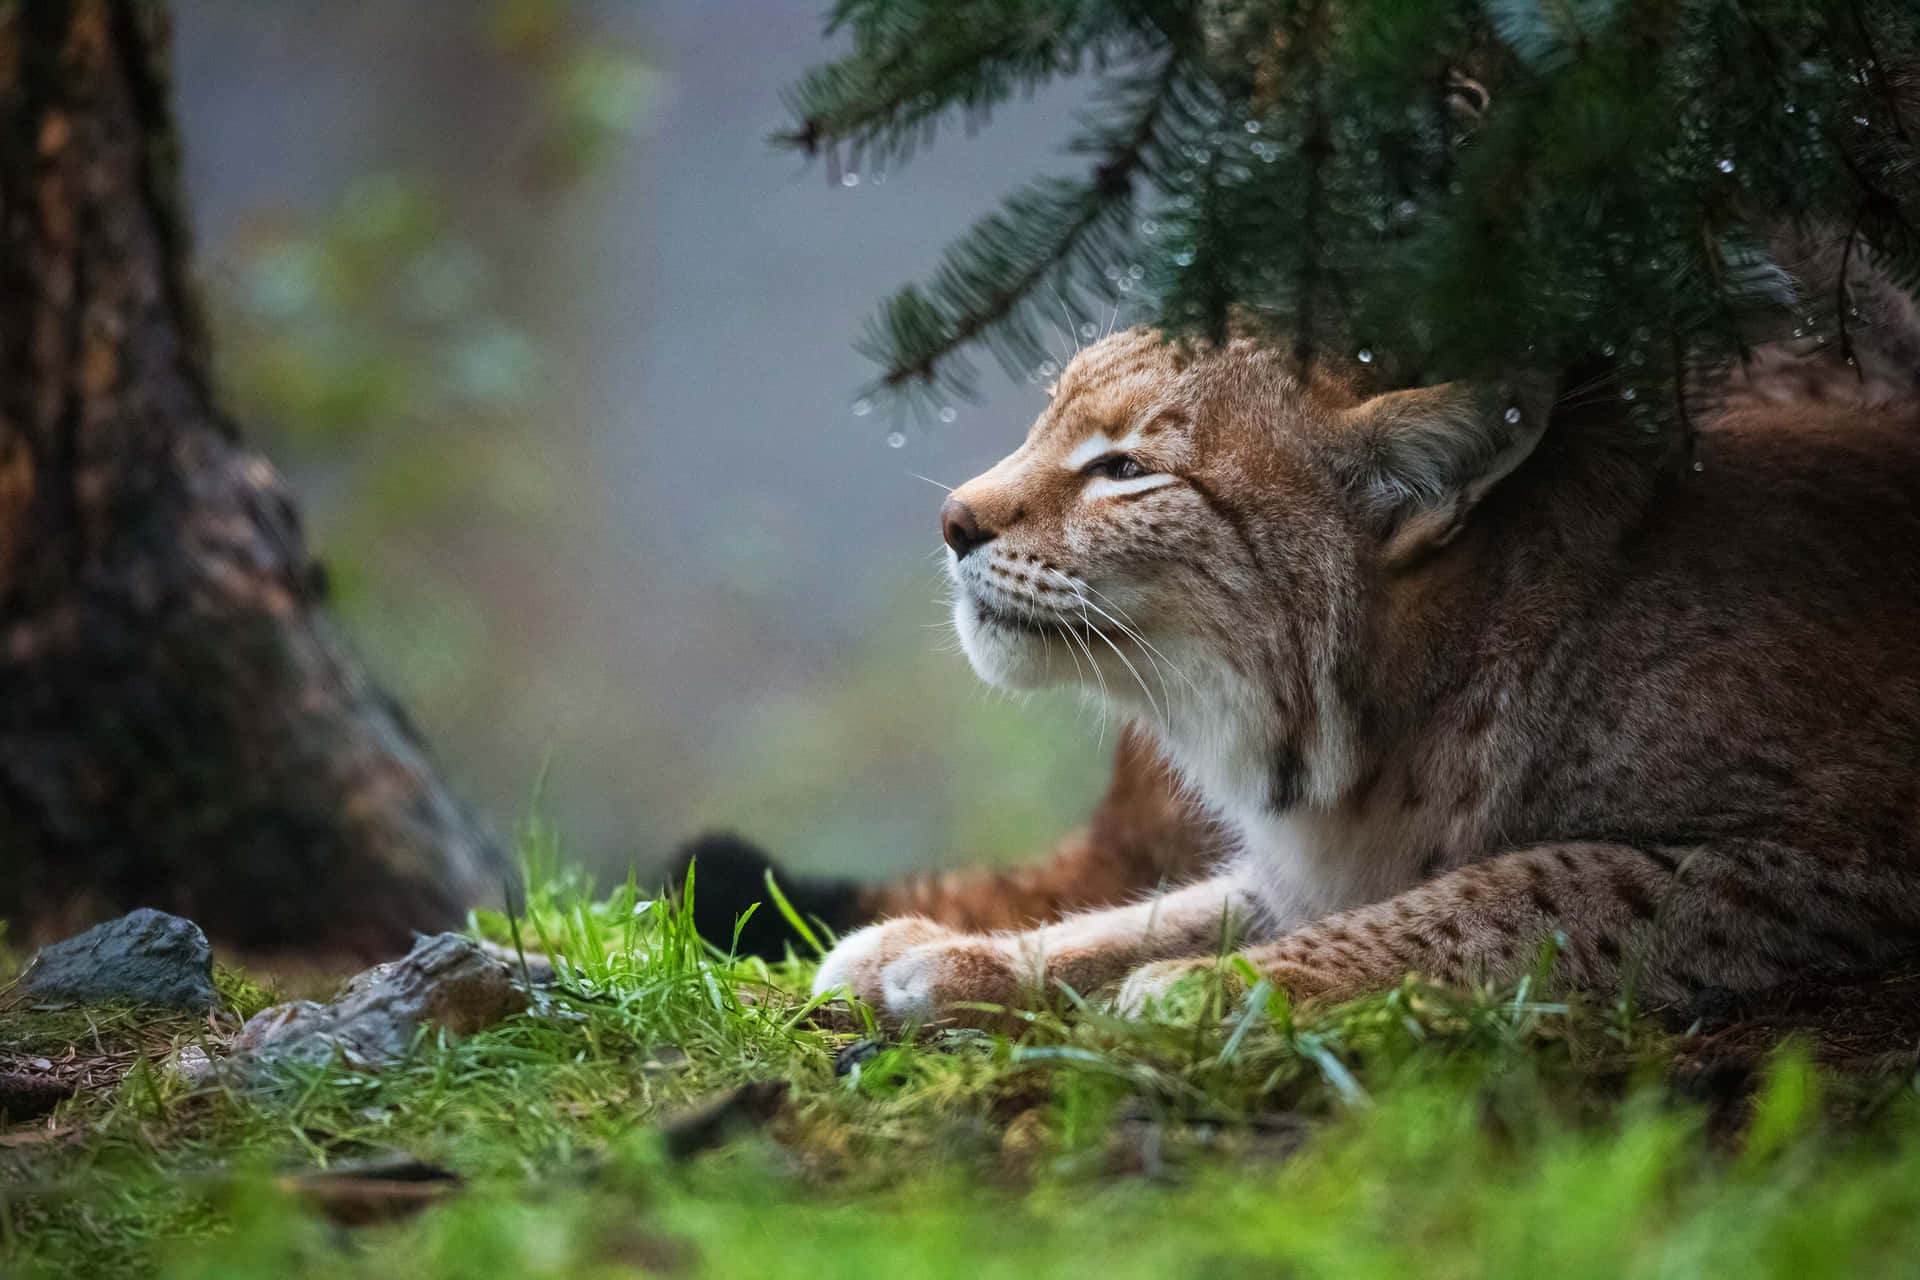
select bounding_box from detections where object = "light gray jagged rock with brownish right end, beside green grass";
[228,933,528,1077]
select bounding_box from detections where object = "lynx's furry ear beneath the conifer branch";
[1340,378,1553,562]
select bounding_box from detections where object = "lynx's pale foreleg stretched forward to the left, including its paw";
[814,879,1254,1021]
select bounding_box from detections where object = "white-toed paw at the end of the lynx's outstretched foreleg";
[814,917,1021,1023]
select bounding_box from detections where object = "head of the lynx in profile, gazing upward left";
[941,330,1546,808]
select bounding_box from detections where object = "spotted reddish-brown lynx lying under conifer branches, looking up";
[802,330,1920,1019]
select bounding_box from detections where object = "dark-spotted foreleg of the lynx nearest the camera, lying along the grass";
[1119,841,1920,1013]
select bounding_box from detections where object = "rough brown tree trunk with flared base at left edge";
[0,0,505,954]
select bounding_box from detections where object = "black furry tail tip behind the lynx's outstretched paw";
[666,831,866,960]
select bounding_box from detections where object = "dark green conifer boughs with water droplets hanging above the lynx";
[798,0,1920,434]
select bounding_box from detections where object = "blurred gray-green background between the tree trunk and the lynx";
[175,0,1110,875]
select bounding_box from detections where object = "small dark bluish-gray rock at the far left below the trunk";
[13,908,213,1013]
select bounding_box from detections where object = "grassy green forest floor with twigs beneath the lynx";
[0,836,1920,1280]
